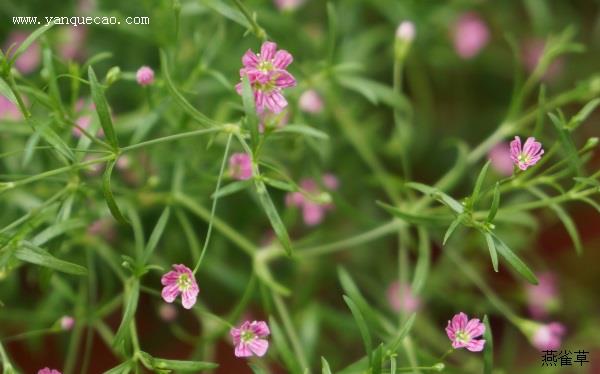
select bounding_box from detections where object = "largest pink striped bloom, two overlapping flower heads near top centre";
[235,42,296,113]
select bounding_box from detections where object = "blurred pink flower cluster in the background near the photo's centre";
[285,173,339,226]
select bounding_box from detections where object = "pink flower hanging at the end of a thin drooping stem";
[160,265,200,309]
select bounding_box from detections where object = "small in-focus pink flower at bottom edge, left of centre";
[229,321,271,357]
